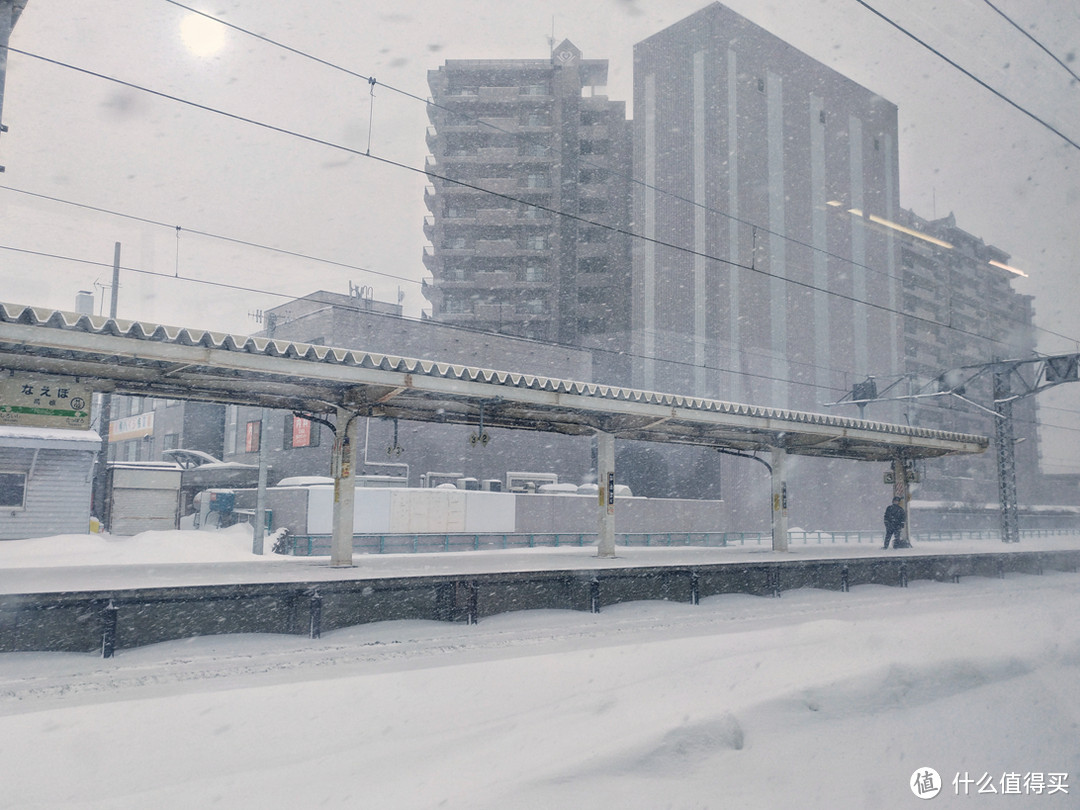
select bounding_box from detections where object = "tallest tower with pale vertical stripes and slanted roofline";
[633,3,900,410]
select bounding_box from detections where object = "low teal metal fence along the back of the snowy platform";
[275,529,1078,556]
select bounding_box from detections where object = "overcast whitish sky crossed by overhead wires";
[0,0,1080,471]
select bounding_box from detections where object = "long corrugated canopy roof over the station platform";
[0,303,988,461]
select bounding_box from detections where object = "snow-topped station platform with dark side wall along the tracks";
[0,536,1080,657]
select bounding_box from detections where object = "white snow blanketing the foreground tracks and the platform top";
[0,532,1080,810]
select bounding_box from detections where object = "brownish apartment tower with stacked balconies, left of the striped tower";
[423,41,631,367]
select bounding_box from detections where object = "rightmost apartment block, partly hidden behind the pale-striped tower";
[894,211,1039,504]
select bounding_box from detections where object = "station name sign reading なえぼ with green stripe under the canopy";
[0,373,94,430]
